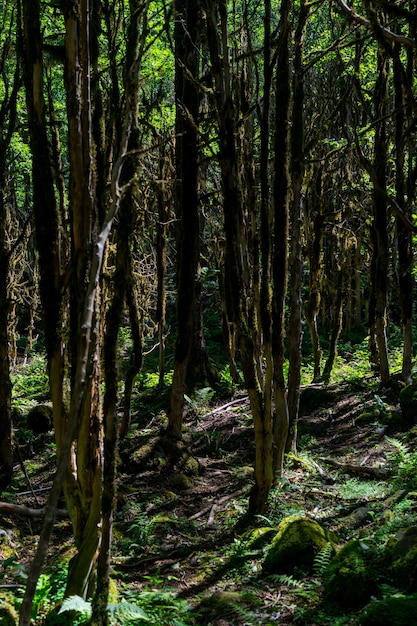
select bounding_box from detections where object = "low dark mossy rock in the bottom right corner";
[360,594,417,626]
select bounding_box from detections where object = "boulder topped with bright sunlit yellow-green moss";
[263,515,335,574]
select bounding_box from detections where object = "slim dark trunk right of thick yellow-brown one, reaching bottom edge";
[91,0,148,626]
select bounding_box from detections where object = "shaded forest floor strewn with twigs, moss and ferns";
[0,372,417,626]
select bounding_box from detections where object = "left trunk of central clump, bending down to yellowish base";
[202,0,273,513]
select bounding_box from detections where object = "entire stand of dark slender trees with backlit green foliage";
[0,0,417,626]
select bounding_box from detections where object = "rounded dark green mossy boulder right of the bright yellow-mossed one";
[324,540,378,609]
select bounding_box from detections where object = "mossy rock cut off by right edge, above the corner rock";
[386,526,417,588]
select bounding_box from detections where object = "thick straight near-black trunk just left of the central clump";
[167,0,200,439]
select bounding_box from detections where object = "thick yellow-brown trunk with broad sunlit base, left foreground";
[63,0,103,598]
